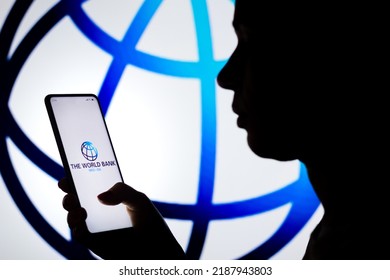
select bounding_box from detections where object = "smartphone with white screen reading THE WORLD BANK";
[45,93,132,233]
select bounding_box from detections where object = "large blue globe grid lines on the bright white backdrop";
[0,0,320,259]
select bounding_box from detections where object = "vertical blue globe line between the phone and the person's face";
[187,0,219,259]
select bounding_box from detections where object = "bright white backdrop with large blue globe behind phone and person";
[0,0,320,259]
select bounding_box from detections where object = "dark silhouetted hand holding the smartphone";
[58,178,185,260]
